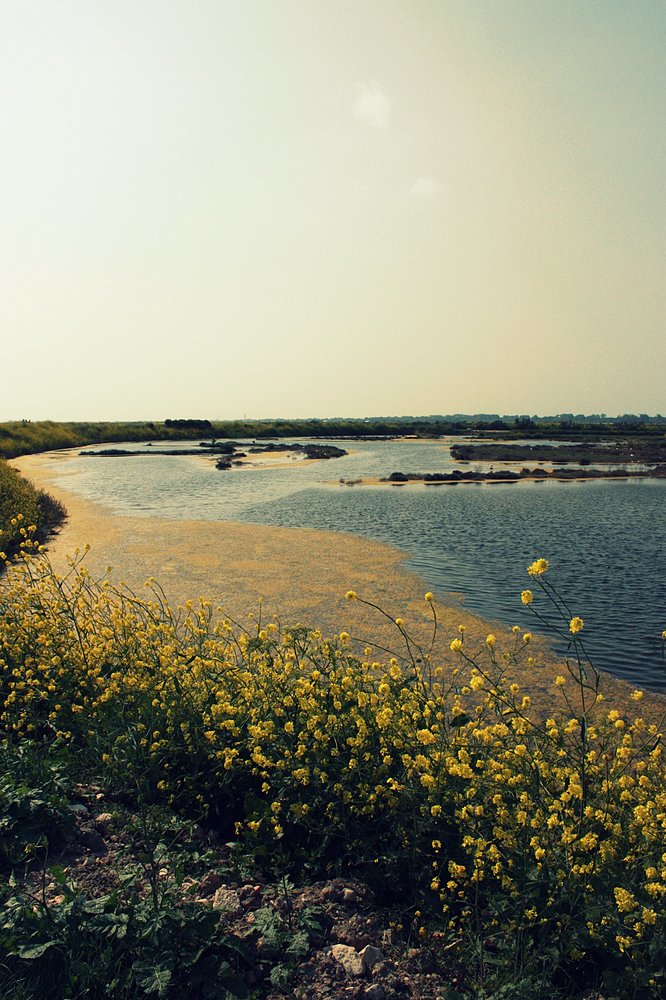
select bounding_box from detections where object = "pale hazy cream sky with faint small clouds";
[0,0,666,420]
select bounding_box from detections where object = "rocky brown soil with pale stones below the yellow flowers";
[26,786,464,1000]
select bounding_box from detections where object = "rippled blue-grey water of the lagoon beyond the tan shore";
[49,441,666,690]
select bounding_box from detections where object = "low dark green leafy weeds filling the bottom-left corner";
[0,876,247,1000]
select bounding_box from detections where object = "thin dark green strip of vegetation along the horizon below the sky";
[0,414,666,458]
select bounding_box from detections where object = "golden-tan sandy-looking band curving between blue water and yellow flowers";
[12,452,666,714]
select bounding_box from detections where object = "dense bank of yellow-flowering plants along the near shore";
[0,538,666,997]
